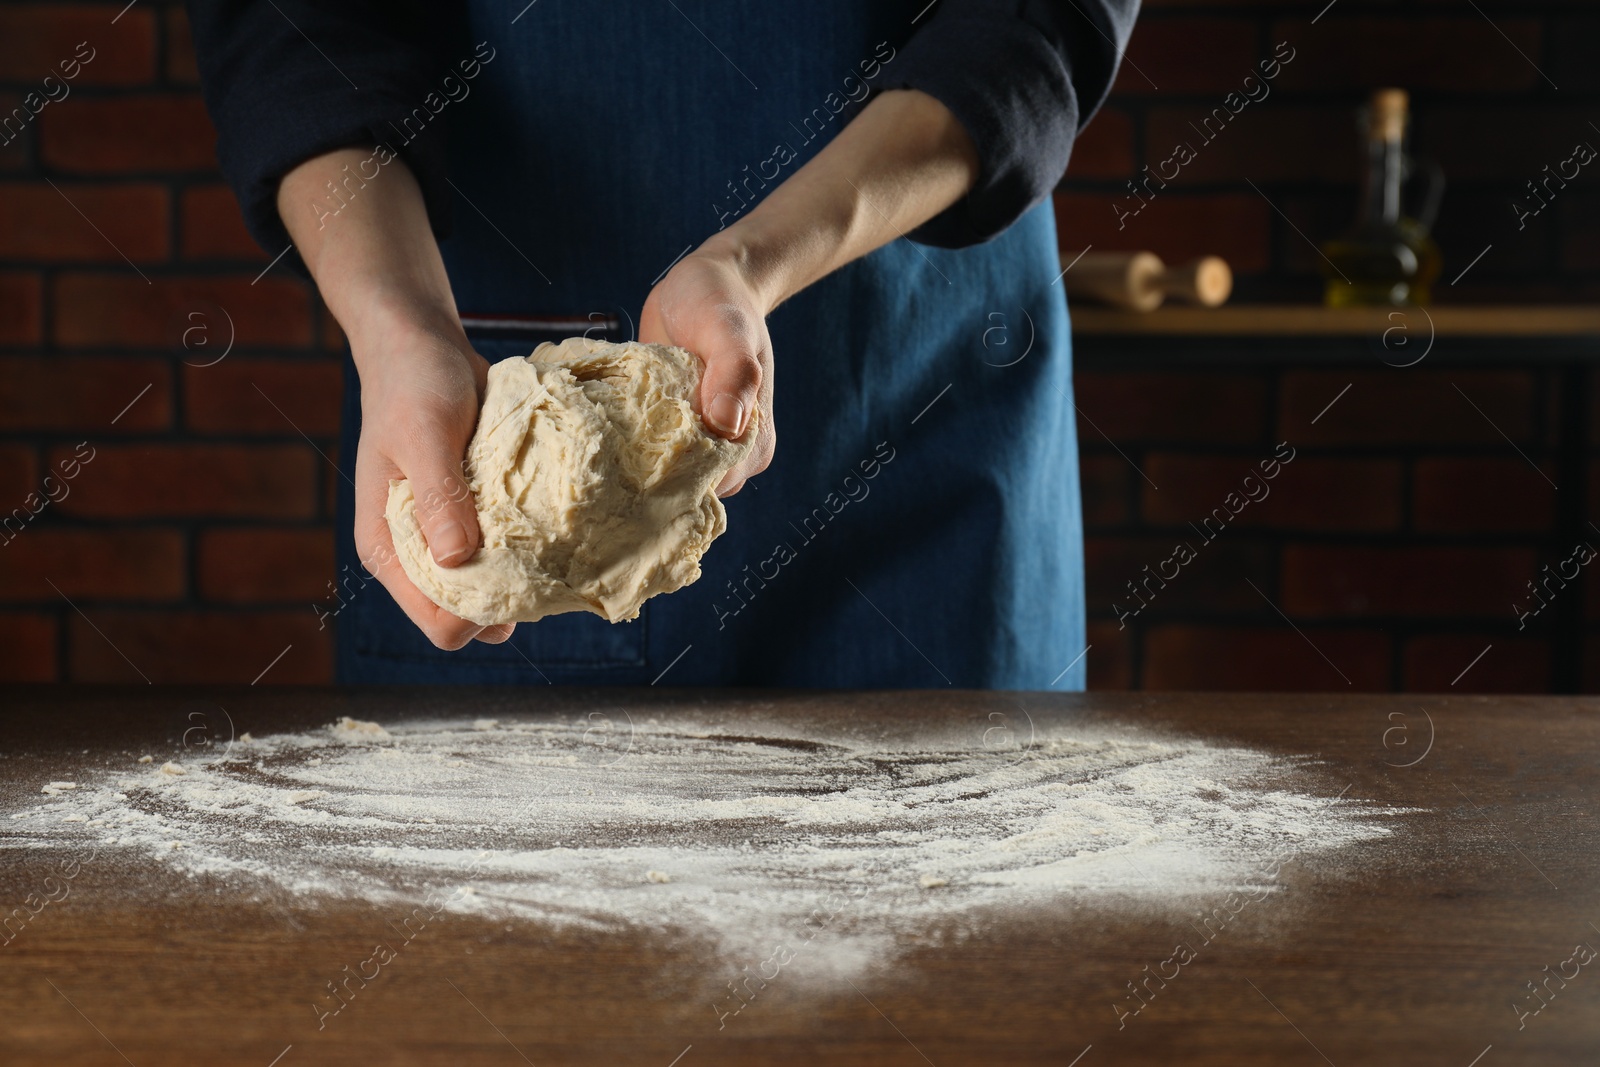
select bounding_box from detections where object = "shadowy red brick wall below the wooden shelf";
[1077,358,1600,693]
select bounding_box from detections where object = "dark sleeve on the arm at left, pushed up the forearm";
[187,0,472,272]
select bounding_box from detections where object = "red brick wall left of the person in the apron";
[0,3,339,683]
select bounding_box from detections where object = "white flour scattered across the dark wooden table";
[0,717,1403,957]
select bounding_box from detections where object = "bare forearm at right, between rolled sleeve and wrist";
[702,90,979,310]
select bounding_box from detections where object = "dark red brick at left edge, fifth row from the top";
[0,355,173,428]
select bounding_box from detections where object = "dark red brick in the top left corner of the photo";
[0,3,155,85]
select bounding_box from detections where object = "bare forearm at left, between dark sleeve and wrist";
[278,149,466,369]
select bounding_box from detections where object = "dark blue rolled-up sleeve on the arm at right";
[885,0,1139,248]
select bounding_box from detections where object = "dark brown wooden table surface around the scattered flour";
[0,688,1600,1067]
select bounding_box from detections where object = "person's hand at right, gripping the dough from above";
[638,238,778,496]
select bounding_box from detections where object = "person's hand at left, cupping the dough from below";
[350,322,515,651]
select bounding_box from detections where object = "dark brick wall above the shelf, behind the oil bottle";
[1056,0,1600,302]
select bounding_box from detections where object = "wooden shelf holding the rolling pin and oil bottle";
[1072,304,1600,338]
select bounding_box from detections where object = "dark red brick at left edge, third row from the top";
[0,182,170,264]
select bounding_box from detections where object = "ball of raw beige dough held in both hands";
[386,338,755,625]
